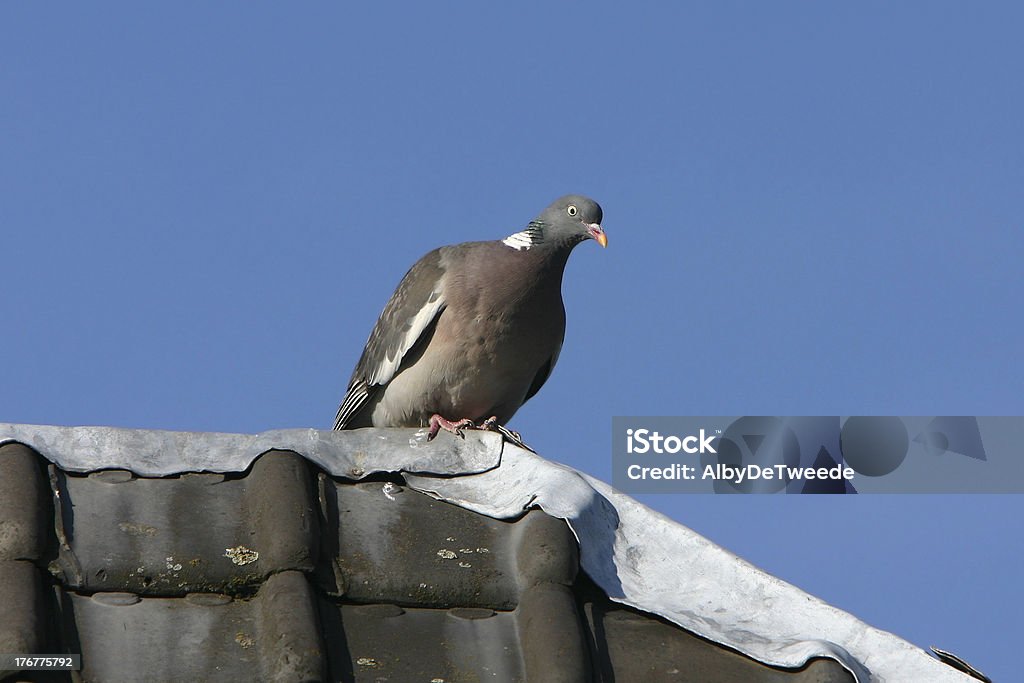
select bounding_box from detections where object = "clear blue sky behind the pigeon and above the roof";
[0,2,1024,680]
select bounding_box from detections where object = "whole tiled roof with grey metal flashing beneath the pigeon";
[0,425,970,683]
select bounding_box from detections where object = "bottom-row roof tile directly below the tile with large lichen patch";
[62,571,326,683]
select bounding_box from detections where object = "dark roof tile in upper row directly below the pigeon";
[321,476,579,609]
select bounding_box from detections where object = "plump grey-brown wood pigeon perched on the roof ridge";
[334,195,606,429]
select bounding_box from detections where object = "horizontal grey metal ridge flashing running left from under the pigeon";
[0,423,503,479]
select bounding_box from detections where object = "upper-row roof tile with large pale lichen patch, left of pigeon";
[53,452,318,596]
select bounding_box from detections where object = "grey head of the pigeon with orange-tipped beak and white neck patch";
[503,195,608,250]
